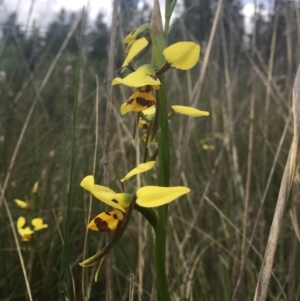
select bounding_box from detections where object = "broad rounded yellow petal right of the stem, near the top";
[163,42,200,70]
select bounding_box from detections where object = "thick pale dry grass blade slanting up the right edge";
[254,65,300,301]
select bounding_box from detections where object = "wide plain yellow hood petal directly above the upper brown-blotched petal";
[112,64,160,88]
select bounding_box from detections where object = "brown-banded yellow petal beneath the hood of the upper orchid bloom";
[120,85,156,115]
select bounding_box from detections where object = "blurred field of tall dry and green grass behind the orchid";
[0,1,300,301]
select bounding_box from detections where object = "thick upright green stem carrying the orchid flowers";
[151,0,173,301]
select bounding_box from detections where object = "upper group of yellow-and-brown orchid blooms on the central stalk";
[112,24,209,141]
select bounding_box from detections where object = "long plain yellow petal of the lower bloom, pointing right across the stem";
[136,186,190,207]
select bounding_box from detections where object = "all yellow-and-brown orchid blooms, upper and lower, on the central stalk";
[80,24,209,266]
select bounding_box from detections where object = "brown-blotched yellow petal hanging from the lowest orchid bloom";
[88,210,124,231]
